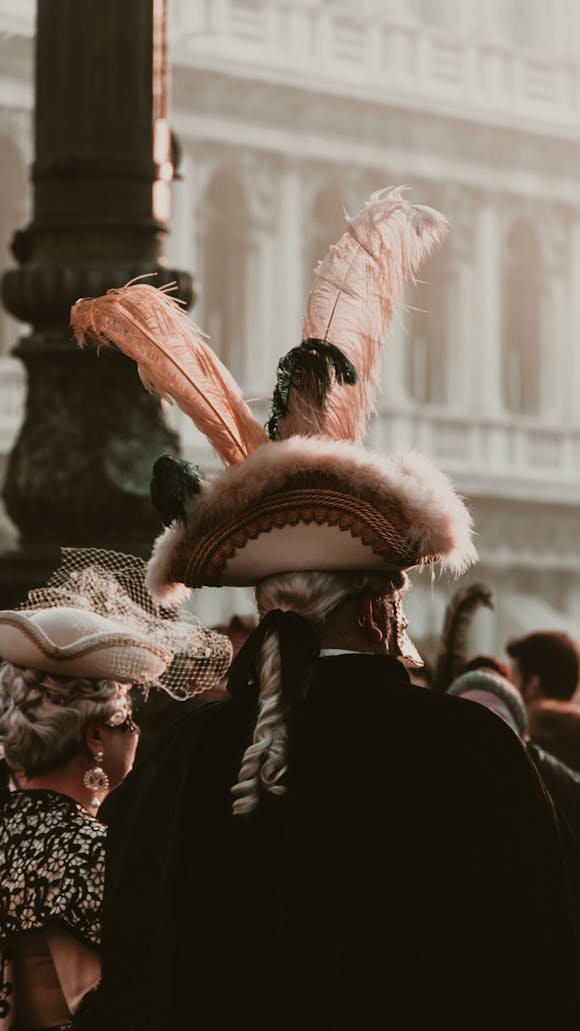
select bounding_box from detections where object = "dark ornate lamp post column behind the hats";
[0,0,192,607]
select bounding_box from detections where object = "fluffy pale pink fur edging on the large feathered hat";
[147,437,477,601]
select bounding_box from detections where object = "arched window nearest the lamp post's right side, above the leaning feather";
[202,169,250,376]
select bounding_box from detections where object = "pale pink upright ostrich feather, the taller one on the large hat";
[276,187,447,443]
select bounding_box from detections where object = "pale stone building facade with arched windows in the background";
[0,0,580,648]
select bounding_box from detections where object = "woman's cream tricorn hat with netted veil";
[0,548,232,698]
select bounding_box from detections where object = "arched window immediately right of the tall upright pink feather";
[405,251,449,404]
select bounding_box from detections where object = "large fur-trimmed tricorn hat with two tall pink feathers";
[71,189,475,603]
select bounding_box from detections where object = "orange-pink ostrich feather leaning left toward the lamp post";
[71,282,267,465]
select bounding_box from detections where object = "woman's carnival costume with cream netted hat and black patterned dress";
[0,550,231,1031]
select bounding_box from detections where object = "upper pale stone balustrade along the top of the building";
[172,0,580,125]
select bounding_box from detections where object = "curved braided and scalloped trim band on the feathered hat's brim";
[183,488,418,587]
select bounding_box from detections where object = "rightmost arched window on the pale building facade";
[503,222,542,415]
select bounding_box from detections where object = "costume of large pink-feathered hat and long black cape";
[72,190,579,1031]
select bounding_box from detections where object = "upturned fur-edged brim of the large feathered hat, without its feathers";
[147,437,476,600]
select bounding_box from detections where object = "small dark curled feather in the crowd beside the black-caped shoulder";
[435,584,493,692]
